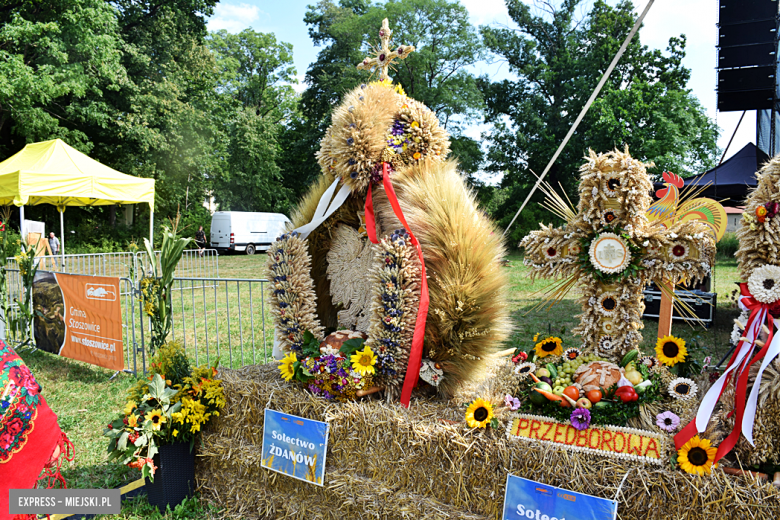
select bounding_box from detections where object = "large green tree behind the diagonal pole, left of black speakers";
[481,0,718,244]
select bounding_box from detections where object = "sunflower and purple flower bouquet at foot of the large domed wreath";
[279,331,382,401]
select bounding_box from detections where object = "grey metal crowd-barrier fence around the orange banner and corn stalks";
[7,250,273,374]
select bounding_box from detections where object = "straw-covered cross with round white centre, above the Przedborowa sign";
[520,149,715,361]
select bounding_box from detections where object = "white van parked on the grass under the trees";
[210,211,290,255]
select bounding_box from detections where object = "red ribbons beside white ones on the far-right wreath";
[674,283,774,462]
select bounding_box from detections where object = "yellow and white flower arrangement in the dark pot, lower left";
[103,342,225,480]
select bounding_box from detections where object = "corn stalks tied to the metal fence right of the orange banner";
[141,215,192,354]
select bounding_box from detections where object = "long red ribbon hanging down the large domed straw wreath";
[366,163,430,408]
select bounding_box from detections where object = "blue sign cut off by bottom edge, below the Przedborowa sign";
[503,475,617,520]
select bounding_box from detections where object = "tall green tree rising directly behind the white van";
[207,29,298,211]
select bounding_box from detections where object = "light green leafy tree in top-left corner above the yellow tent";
[0,0,127,157]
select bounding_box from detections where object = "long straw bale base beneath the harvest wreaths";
[196,366,780,520]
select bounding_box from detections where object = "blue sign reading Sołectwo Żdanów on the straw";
[261,409,329,486]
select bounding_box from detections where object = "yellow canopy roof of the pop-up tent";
[0,139,154,211]
